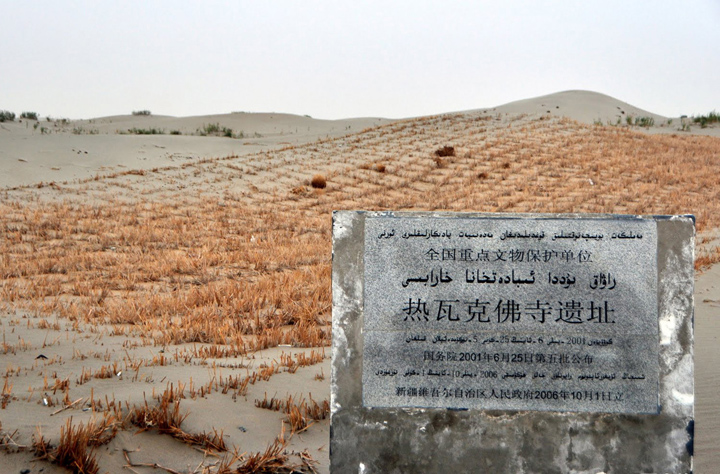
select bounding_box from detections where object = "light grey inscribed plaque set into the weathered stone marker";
[363,214,659,413]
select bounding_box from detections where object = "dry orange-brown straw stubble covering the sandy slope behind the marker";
[0,114,720,472]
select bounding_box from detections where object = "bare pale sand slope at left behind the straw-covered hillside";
[0,113,390,188]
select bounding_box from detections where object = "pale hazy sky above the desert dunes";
[0,0,720,118]
